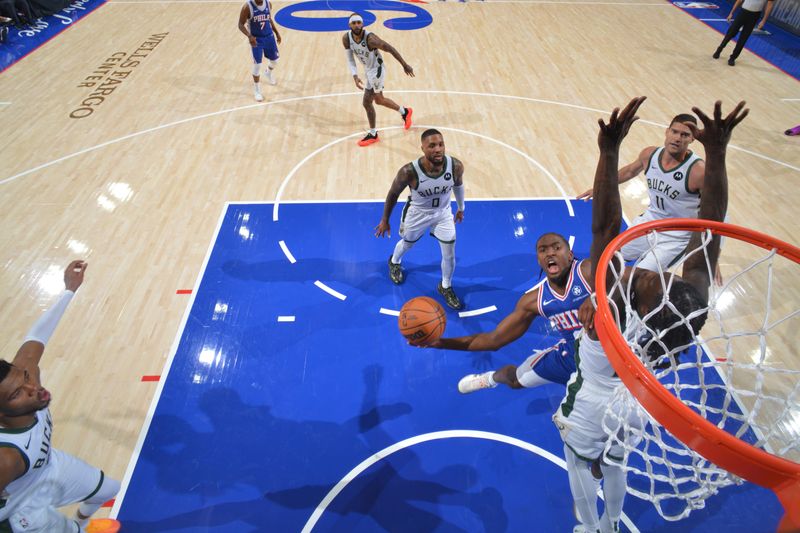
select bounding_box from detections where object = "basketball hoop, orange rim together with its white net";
[594,219,800,532]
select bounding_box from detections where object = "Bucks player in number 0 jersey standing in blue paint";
[375,129,464,309]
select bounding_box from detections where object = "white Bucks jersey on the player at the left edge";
[0,409,53,499]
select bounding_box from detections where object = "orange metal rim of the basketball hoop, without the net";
[594,218,800,531]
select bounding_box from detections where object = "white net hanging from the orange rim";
[603,227,800,520]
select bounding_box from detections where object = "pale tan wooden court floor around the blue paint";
[0,0,800,524]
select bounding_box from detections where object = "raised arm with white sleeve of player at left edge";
[12,261,87,379]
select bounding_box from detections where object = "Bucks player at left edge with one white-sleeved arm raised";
[0,261,120,533]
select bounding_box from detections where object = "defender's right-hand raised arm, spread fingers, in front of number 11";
[683,100,750,298]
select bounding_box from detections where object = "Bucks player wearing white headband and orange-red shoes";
[342,13,414,146]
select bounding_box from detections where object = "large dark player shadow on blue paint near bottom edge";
[125,365,508,532]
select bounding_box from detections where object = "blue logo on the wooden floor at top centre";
[275,0,433,32]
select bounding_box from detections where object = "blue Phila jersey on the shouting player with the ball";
[539,261,592,354]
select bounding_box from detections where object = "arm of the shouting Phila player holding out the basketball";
[429,289,539,352]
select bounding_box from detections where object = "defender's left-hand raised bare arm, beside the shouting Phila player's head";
[589,96,647,284]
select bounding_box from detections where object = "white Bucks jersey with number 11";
[644,146,700,220]
